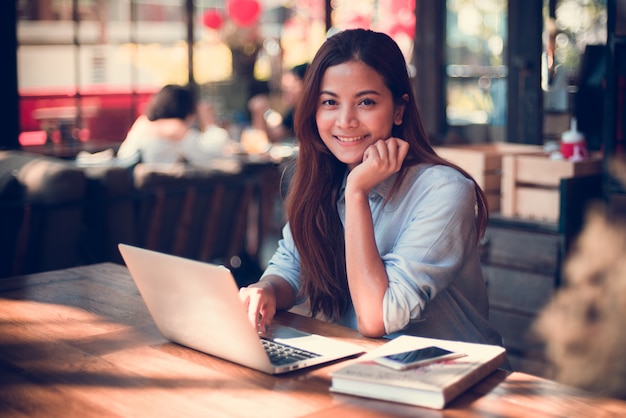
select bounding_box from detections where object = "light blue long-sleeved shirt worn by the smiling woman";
[263,164,502,345]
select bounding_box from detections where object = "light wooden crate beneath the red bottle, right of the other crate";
[500,155,602,222]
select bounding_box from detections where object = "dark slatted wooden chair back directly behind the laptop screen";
[134,164,258,284]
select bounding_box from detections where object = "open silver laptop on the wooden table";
[119,244,364,374]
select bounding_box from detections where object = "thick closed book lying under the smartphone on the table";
[330,335,506,409]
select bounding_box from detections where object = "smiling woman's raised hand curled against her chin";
[348,137,409,194]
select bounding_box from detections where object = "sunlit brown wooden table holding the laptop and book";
[0,263,626,418]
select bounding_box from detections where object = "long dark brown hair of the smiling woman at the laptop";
[286,29,488,320]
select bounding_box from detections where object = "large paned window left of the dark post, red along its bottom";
[17,0,188,145]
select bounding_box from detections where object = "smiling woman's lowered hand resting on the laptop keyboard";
[239,281,276,332]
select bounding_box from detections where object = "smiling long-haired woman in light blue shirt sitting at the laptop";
[240,29,501,344]
